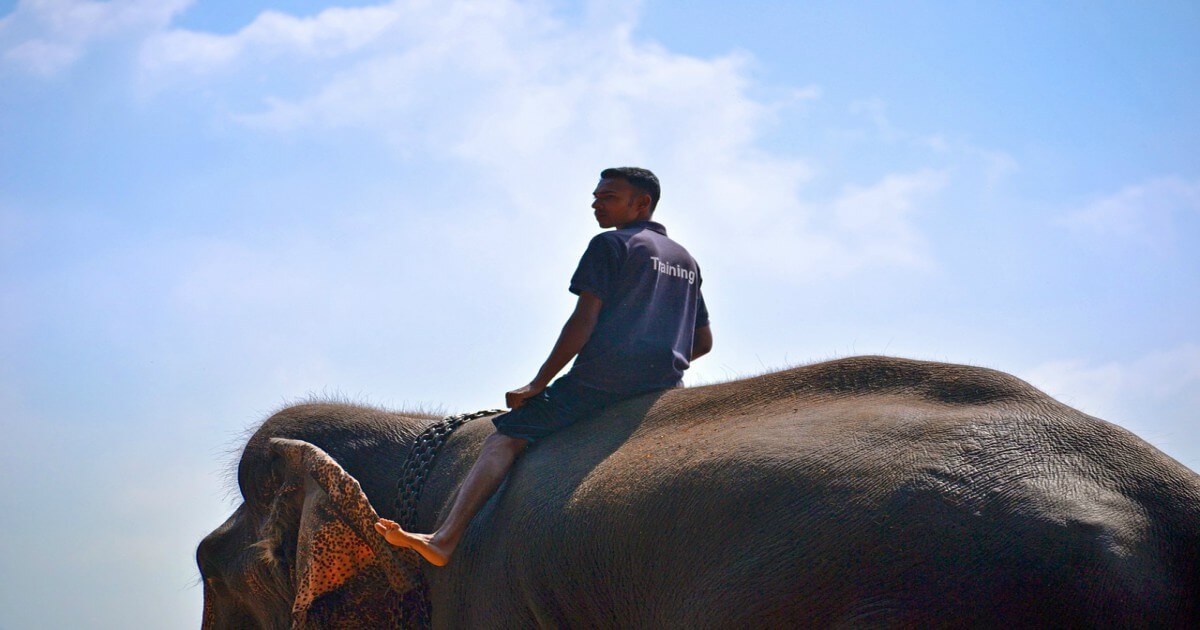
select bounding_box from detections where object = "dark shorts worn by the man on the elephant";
[492,374,636,443]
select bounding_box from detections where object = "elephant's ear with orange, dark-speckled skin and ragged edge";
[271,438,420,628]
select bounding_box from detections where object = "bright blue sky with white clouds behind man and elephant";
[0,0,1200,629]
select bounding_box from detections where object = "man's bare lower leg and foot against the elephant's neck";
[376,433,529,566]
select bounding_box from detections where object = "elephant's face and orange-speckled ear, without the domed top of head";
[204,438,429,629]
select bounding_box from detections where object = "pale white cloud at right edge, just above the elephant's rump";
[1019,343,1200,468]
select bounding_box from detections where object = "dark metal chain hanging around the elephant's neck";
[396,409,504,628]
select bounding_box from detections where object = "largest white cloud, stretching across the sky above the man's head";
[136,0,949,282]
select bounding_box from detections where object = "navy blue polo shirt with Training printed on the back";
[569,221,708,394]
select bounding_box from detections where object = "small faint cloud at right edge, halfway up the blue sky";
[1063,176,1200,248]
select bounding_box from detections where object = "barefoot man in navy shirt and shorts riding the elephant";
[376,167,713,566]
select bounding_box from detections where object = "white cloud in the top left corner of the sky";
[0,0,192,76]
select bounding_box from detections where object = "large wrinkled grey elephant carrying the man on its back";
[198,356,1200,628]
